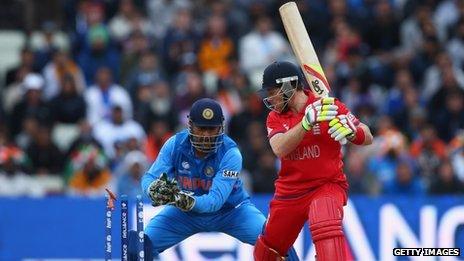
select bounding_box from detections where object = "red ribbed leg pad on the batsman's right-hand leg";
[309,197,346,261]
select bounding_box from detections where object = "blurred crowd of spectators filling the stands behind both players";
[0,0,464,195]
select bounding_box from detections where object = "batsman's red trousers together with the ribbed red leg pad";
[260,183,347,260]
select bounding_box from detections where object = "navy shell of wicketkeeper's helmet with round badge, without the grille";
[189,98,224,127]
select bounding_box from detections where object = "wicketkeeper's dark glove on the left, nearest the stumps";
[148,173,180,207]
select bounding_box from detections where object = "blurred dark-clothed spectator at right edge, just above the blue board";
[429,160,464,194]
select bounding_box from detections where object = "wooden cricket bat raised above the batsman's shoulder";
[279,2,330,97]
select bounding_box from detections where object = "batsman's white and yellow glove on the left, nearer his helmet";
[301,98,338,131]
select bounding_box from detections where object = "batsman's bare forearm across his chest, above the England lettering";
[269,124,307,158]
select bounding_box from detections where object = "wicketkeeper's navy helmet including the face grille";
[188,98,224,153]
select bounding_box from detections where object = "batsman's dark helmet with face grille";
[259,61,304,113]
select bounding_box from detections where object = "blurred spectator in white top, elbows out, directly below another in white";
[93,104,145,159]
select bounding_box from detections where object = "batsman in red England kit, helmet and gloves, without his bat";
[253,62,373,261]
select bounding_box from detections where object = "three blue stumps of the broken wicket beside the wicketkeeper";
[105,189,145,261]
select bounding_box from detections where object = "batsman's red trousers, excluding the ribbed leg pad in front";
[262,183,347,256]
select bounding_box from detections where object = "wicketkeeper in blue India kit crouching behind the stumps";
[129,98,298,260]
